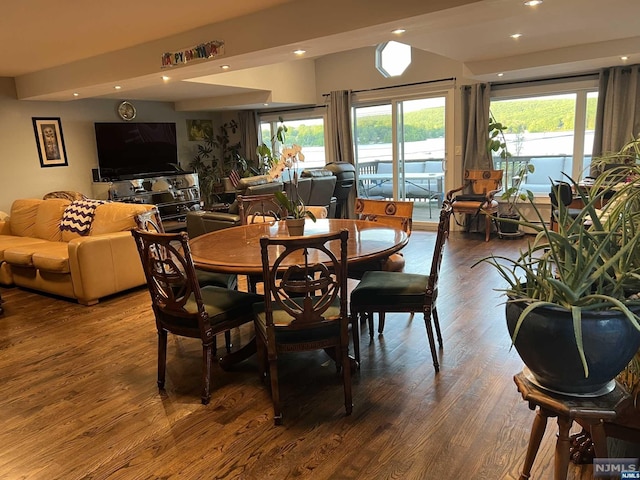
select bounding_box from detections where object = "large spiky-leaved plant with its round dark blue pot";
[476,159,640,396]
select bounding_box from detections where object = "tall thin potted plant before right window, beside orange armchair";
[487,115,535,238]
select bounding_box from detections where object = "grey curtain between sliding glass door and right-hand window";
[462,83,493,170]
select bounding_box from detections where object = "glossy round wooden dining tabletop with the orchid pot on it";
[189,218,409,275]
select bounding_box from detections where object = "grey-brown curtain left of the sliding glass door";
[328,90,358,218]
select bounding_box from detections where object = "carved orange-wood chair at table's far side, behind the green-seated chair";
[348,198,413,280]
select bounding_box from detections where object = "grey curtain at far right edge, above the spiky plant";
[592,65,640,164]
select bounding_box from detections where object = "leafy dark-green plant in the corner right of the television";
[189,120,249,208]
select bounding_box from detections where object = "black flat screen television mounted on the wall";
[95,122,180,180]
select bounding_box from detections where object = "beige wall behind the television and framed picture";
[0,78,219,213]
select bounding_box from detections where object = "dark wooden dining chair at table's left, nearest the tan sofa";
[131,229,262,405]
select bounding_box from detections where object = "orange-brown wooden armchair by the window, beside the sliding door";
[447,170,503,242]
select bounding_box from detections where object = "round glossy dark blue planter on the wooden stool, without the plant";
[506,303,640,396]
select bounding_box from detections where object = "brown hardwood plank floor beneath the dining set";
[0,232,591,480]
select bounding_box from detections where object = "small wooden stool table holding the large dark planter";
[513,372,630,480]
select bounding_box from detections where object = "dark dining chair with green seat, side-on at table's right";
[350,200,453,372]
